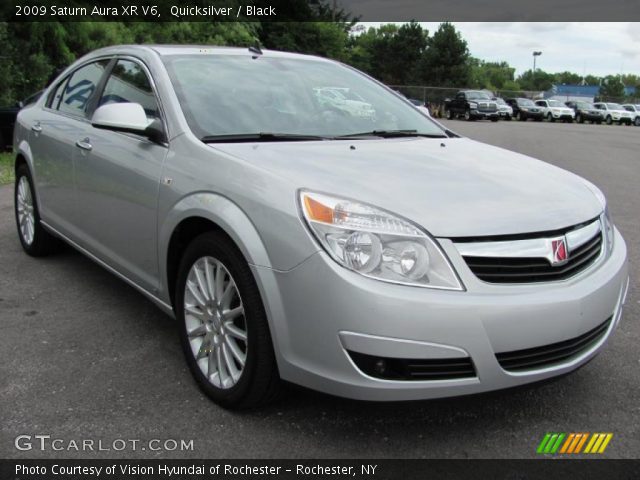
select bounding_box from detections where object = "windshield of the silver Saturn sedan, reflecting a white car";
[163,54,446,141]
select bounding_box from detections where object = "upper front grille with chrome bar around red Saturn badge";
[456,220,603,283]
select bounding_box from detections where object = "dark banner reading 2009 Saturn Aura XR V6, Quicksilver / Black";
[0,0,640,22]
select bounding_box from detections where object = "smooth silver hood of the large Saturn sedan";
[211,138,602,238]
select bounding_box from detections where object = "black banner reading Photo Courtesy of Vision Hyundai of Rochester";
[0,458,640,480]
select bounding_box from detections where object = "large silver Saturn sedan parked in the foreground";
[14,46,628,408]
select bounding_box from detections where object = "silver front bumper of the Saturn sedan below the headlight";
[253,231,628,401]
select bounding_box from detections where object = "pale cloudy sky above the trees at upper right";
[363,22,640,76]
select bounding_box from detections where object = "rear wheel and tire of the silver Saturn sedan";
[13,163,61,257]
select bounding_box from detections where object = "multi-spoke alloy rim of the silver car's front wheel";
[184,257,248,389]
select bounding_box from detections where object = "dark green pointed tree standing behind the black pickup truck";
[420,22,471,87]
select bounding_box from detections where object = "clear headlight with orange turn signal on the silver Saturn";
[300,191,464,290]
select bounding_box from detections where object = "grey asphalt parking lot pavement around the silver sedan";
[0,121,640,458]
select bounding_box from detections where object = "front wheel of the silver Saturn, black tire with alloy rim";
[174,232,281,409]
